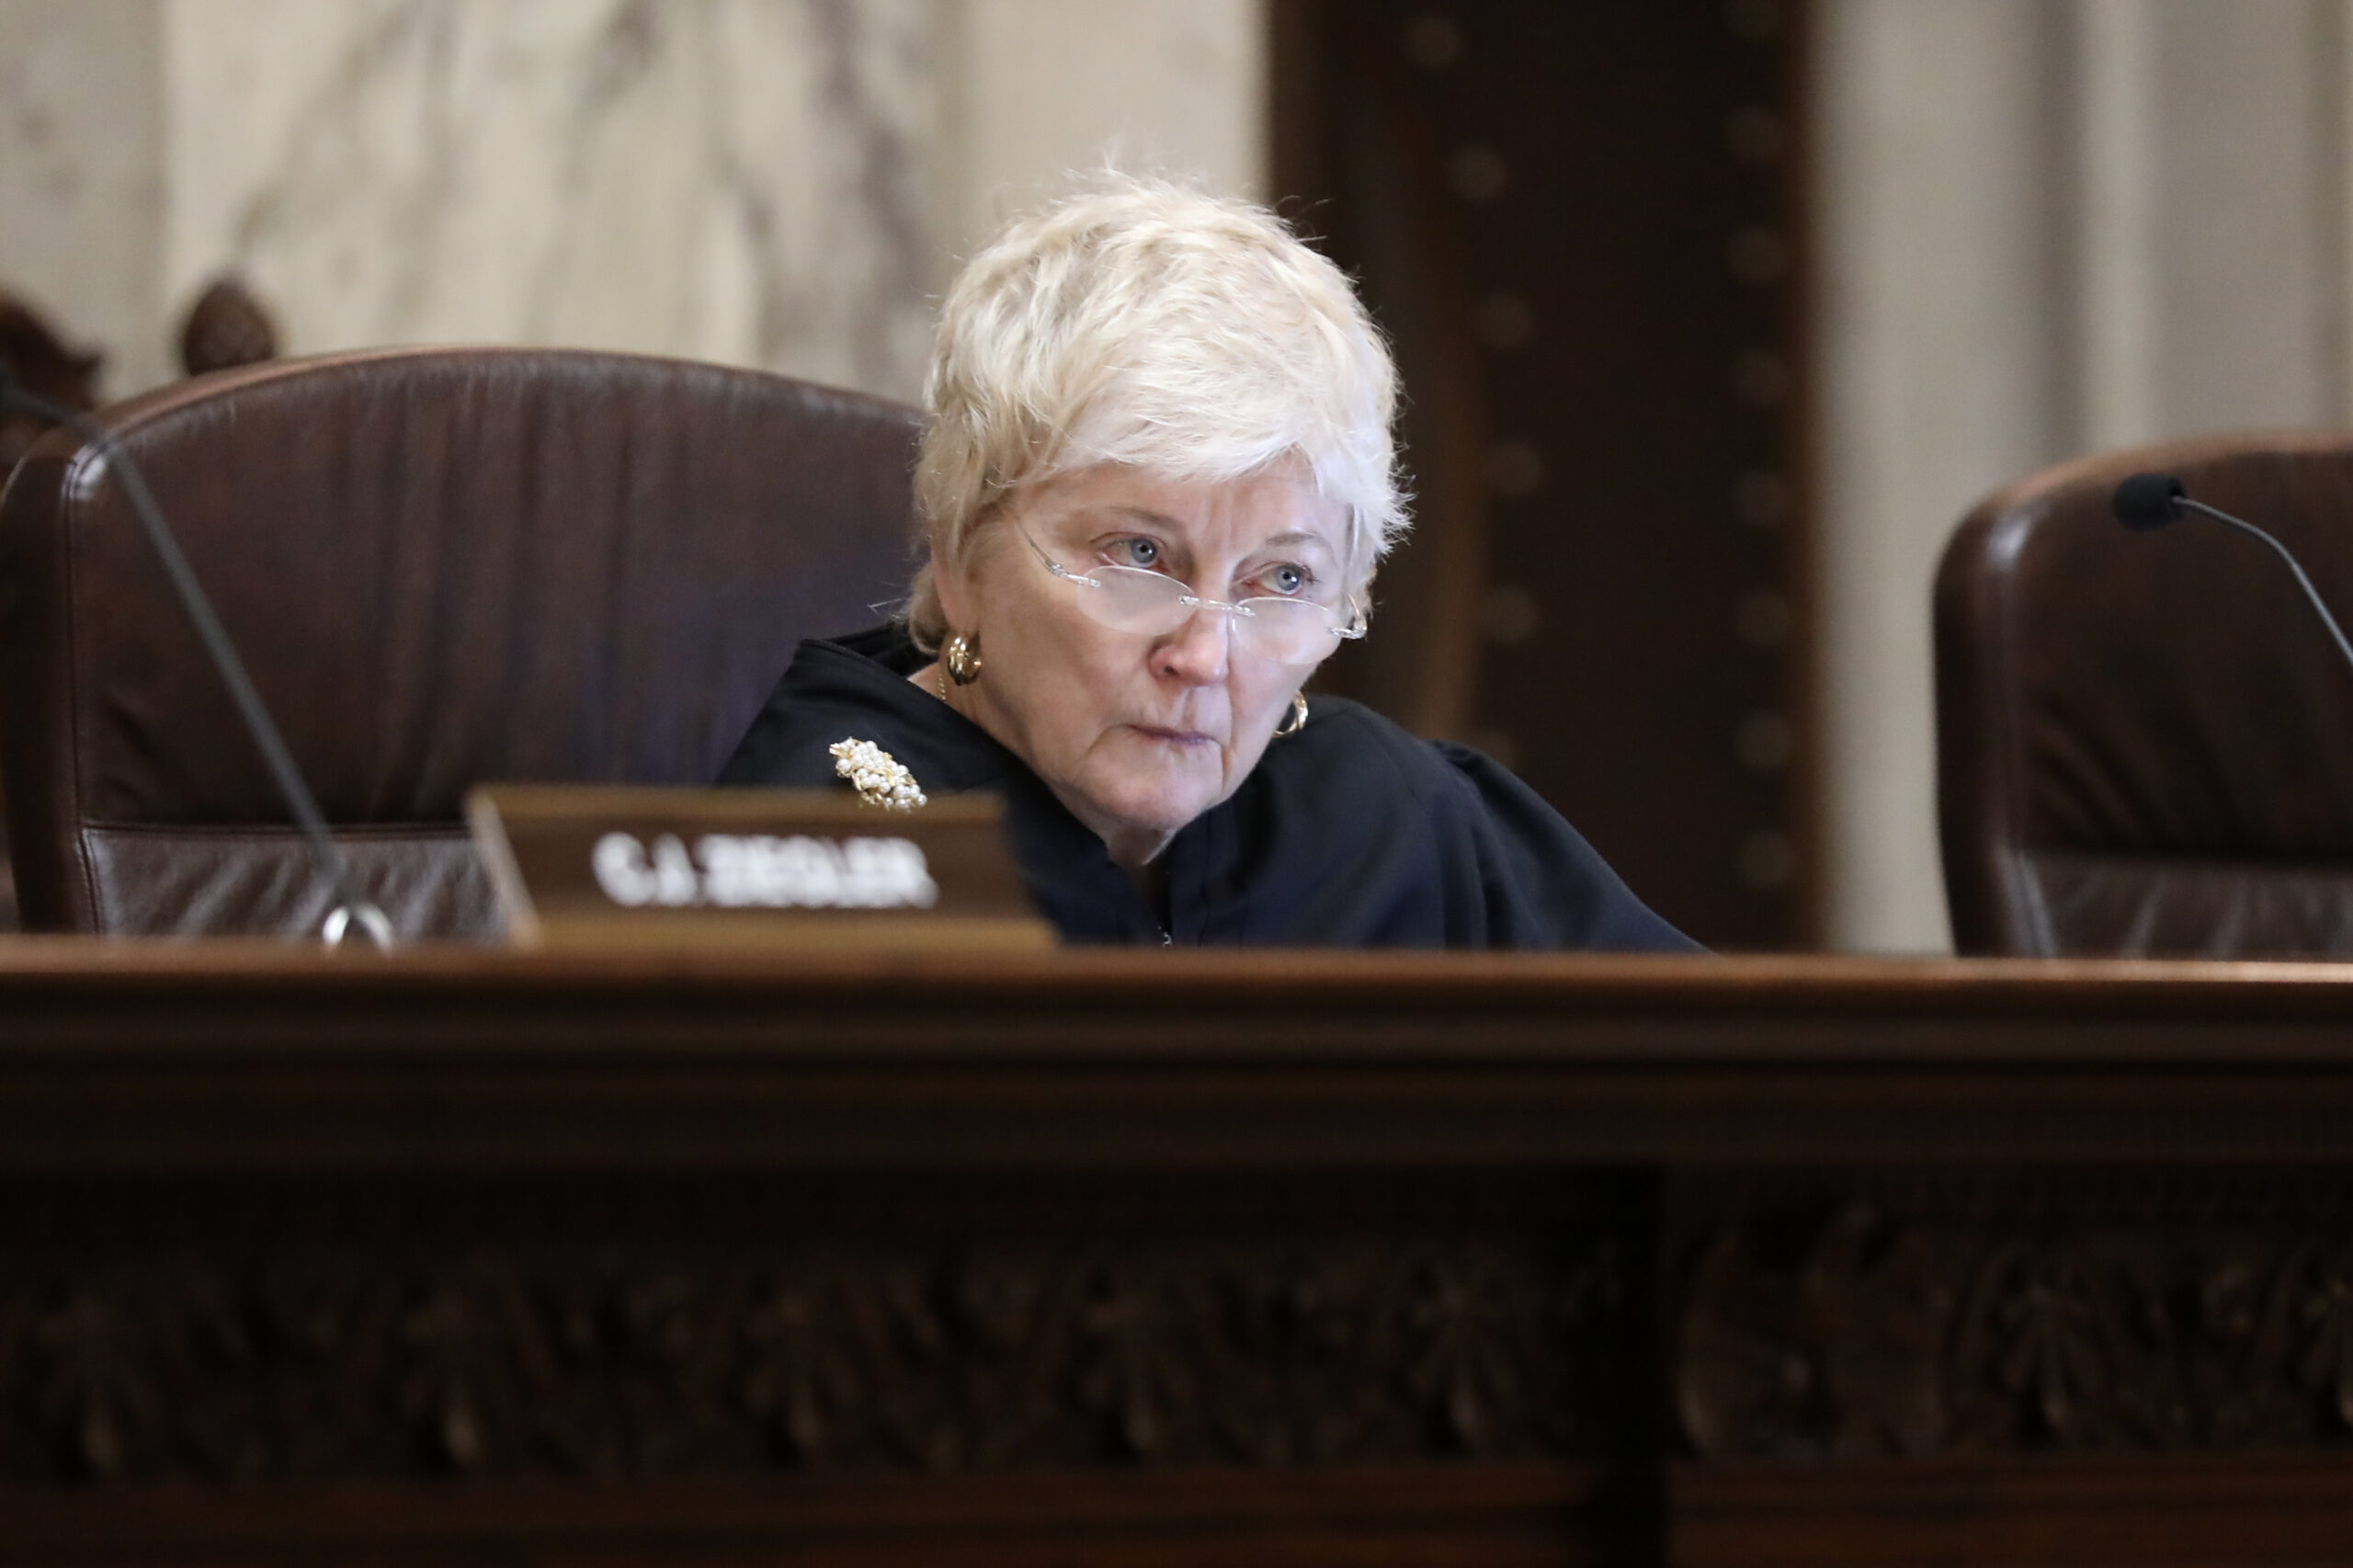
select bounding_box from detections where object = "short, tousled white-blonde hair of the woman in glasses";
[908,175,1407,650]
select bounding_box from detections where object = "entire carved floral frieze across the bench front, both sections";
[18,1153,2353,1485]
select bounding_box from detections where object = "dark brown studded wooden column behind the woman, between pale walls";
[1273,0,1816,947]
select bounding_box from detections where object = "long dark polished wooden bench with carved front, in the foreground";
[0,939,2353,1565]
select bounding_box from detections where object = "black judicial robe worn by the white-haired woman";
[720,626,1697,951]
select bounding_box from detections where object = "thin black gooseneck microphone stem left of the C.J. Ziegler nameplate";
[0,362,393,951]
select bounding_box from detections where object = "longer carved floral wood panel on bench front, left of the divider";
[0,1179,1635,1485]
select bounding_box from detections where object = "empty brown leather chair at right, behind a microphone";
[1937,433,2353,956]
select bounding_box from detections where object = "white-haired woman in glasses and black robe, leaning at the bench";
[722,179,1689,949]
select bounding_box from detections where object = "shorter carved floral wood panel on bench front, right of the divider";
[1676,1173,2353,1460]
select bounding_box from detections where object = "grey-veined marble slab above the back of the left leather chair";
[165,0,937,393]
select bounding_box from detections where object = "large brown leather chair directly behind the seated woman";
[0,348,920,937]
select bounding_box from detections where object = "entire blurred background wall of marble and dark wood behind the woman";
[0,0,2353,949]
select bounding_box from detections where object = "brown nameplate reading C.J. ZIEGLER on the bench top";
[466,784,1054,949]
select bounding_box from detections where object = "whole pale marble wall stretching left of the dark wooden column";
[0,0,1264,395]
